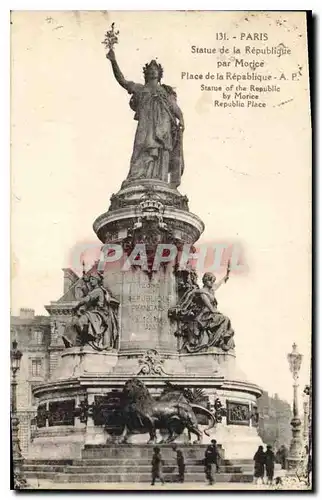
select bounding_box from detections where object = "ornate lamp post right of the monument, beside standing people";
[287,344,303,472]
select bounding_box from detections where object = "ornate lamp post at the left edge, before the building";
[10,340,26,489]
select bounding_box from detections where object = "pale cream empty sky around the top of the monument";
[11,11,311,401]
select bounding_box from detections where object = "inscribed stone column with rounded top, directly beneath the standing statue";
[94,180,204,376]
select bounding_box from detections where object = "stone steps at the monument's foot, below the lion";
[24,445,254,483]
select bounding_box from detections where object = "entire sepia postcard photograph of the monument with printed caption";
[8,10,314,492]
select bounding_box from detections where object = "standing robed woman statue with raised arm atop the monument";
[106,47,184,187]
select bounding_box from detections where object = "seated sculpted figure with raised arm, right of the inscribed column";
[169,271,235,352]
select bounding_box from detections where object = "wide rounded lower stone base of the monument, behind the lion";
[29,347,263,460]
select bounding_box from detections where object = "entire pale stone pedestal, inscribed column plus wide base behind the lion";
[30,180,262,466]
